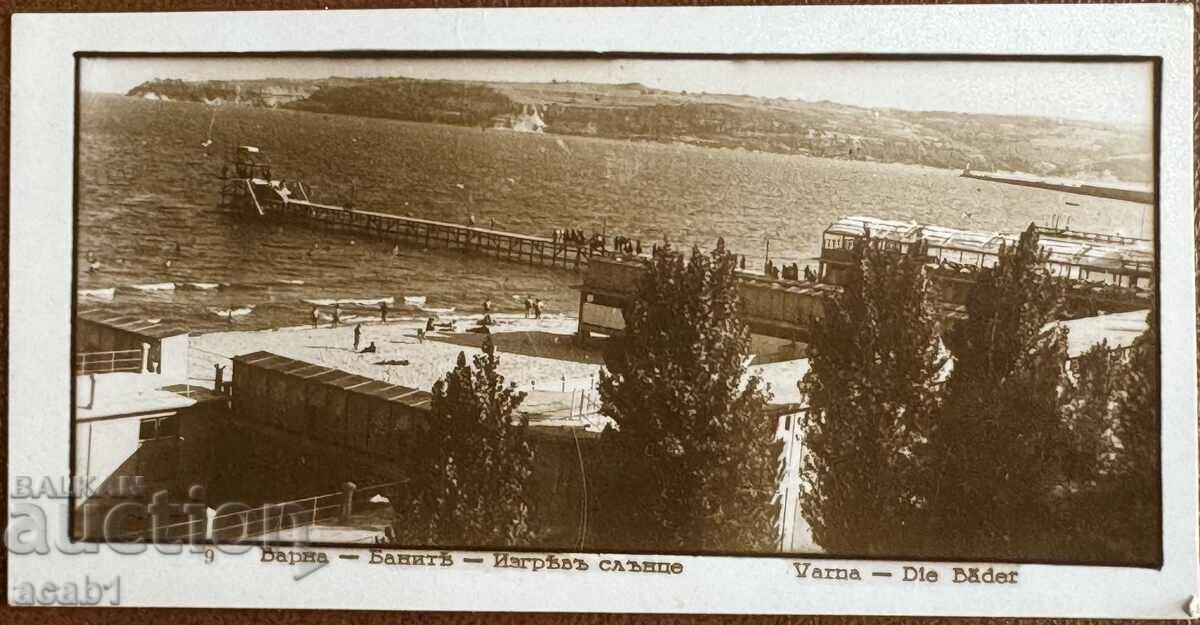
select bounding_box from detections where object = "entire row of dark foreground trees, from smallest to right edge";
[395,228,1160,564]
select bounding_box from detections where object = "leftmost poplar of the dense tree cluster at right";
[800,238,947,555]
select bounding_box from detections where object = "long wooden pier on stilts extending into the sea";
[250,185,609,271]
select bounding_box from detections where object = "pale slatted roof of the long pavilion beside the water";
[826,216,1154,272]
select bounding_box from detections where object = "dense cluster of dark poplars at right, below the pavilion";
[802,227,1160,564]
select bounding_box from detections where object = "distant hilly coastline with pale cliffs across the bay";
[119,78,1153,182]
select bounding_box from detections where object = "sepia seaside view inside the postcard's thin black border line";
[71,53,1163,568]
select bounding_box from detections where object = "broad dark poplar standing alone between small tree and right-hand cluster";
[594,241,782,551]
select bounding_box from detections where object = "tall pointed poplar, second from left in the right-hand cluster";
[928,224,1070,558]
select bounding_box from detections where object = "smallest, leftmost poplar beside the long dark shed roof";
[392,336,534,547]
